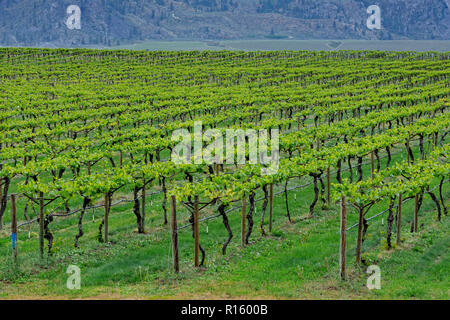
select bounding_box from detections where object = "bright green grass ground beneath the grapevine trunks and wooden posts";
[0,141,450,299]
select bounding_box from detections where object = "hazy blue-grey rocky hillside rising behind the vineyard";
[0,0,450,47]
